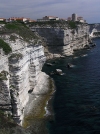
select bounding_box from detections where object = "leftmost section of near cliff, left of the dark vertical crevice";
[0,55,11,112]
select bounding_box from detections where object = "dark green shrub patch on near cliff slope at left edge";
[0,39,12,54]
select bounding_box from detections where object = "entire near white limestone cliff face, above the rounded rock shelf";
[0,32,46,123]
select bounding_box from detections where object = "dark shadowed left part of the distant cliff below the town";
[36,28,64,54]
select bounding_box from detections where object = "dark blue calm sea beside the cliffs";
[43,38,100,134]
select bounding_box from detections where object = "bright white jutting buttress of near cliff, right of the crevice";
[9,45,45,123]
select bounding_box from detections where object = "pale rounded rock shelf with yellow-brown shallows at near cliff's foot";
[22,72,55,134]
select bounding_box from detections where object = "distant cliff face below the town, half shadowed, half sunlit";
[31,24,89,55]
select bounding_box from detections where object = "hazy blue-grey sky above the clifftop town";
[0,0,100,23]
